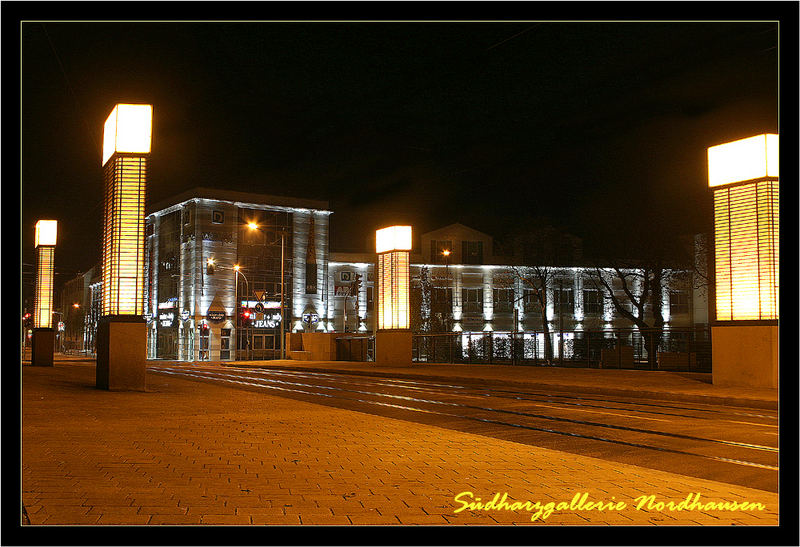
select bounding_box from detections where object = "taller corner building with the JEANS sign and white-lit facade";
[145,188,331,361]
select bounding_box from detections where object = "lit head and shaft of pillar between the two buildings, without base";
[375,226,411,330]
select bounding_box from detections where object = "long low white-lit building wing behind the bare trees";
[325,224,707,337]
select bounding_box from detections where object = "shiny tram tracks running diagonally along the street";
[151,366,779,490]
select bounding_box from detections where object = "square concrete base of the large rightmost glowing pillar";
[711,324,778,388]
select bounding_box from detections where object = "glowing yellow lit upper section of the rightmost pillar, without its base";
[708,135,780,321]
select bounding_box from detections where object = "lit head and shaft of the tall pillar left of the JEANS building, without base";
[103,104,152,315]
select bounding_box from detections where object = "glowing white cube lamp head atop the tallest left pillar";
[103,104,153,165]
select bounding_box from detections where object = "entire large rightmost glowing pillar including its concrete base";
[708,134,779,388]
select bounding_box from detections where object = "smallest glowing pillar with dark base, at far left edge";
[31,220,58,367]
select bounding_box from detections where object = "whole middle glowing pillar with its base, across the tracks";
[375,226,411,367]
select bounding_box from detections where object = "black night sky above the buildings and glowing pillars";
[21,18,780,300]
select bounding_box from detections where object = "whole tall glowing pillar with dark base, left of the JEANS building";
[96,104,153,391]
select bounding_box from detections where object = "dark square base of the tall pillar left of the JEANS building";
[95,315,147,391]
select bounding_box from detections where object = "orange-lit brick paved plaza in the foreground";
[22,362,778,525]
